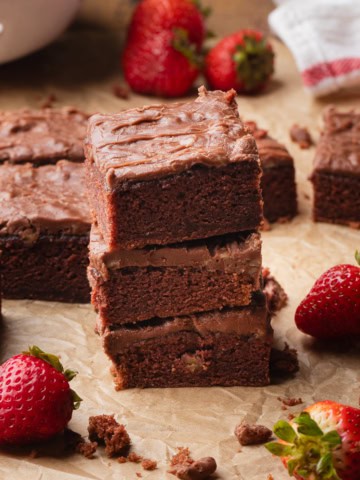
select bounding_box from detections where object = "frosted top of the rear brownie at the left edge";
[0,107,88,165]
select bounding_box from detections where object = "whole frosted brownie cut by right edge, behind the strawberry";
[311,107,360,228]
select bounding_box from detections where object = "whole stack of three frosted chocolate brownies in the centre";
[86,88,272,388]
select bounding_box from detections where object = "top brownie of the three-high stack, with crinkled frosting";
[85,87,262,249]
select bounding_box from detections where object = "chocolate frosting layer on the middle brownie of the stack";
[90,226,261,288]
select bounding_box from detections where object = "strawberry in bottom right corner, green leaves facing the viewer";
[265,400,360,480]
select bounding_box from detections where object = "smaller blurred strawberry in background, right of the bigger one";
[205,30,274,93]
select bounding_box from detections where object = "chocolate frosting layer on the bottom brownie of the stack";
[98,300,271,355]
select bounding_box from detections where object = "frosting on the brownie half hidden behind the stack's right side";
[244,121,294,169]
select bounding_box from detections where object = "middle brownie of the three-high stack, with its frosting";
[88,226,261,325]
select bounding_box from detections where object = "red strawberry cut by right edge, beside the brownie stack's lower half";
[295,252,360,339]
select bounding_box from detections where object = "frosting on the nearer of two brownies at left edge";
[0,160,90,244]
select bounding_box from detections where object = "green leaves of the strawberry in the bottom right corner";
[265,412,342,480]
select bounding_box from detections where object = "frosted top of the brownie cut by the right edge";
[314,107,360,175]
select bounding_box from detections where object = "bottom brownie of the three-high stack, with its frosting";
[98,293,272,389]
